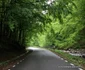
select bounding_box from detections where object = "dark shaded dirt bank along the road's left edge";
[0,52,27,70]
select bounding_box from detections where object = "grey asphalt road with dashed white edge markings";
[9,48,81,70]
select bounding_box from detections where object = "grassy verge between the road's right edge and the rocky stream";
[52,50,85,70]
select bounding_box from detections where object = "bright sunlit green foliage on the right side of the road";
[28,0,85,49]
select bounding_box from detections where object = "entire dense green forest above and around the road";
[0,0,85,50]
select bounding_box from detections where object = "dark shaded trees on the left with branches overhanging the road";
[0,0,75,50]
